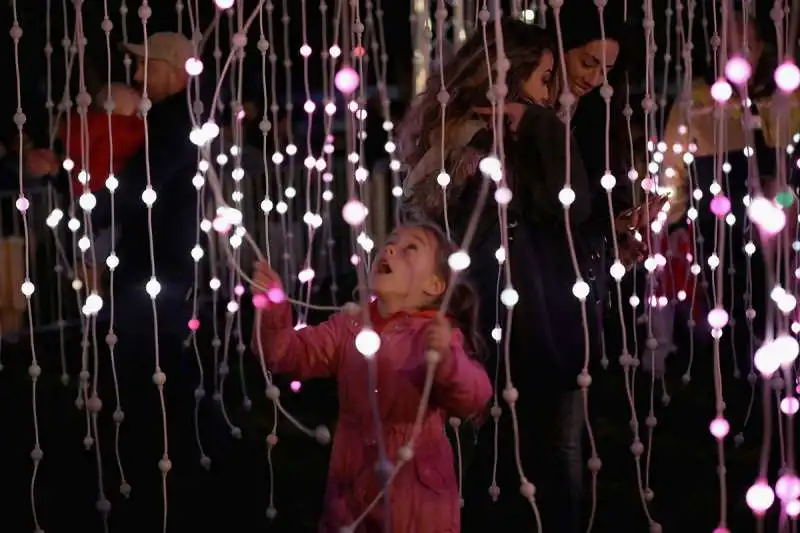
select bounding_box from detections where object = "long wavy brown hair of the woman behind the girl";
[398,17,558,168]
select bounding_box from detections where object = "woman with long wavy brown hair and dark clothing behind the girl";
[399,11,656,533]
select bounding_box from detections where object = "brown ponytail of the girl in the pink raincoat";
[398,222,483,359]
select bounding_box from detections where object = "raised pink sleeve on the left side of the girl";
[252,303,346,379]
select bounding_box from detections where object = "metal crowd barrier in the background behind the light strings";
[0,151,392,339]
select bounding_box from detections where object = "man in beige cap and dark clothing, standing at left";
[25,33,210,531]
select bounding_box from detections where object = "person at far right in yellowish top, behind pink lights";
[662,11,800,377]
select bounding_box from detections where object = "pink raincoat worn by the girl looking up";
[257,304,492,533]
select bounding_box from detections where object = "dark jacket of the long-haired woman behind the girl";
[408,105,610,389]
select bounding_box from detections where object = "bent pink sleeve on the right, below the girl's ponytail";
[432,330,492,418]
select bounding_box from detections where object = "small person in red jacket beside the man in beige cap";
[61,83,145,290]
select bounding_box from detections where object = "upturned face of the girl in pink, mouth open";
[369,227,445,310]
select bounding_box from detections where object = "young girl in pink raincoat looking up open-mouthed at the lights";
[253,224,492,533]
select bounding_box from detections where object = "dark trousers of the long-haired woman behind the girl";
[462,390,585,533]
